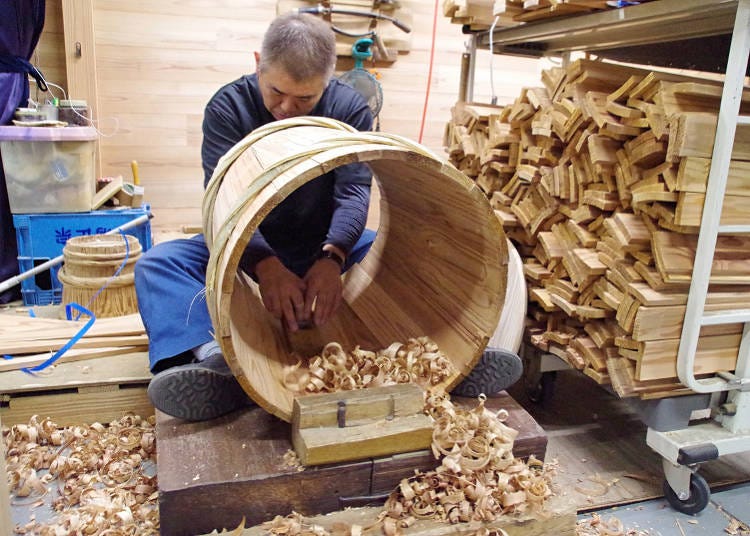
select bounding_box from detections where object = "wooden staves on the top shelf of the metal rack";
[443,0,650,30]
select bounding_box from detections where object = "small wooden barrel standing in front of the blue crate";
[57,234,141,317]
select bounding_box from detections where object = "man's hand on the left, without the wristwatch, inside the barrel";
[255,257,308,332]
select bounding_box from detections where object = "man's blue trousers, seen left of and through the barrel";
[135,229,375,370]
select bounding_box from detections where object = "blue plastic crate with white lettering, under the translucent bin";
[13,205,151,305]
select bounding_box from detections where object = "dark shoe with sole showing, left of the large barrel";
[148,354,252,421]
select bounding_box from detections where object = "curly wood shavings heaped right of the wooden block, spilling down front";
[263,392,555,536]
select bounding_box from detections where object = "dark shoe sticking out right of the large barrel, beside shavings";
[452,348,523,398]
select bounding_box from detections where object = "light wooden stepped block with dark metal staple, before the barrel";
[292,384,434,466]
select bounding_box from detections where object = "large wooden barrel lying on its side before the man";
[203,117,508,421]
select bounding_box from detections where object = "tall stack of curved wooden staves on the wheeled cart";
[445,60,750,398]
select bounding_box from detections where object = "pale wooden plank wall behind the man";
[38,0,540,228]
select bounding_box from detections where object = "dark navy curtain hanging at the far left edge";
[0,0,45,303]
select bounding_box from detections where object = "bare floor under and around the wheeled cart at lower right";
[509,370,750,536]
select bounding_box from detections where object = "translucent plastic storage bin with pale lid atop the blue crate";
[0,126,97,214]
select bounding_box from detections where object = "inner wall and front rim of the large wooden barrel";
[212,127,508,420]
